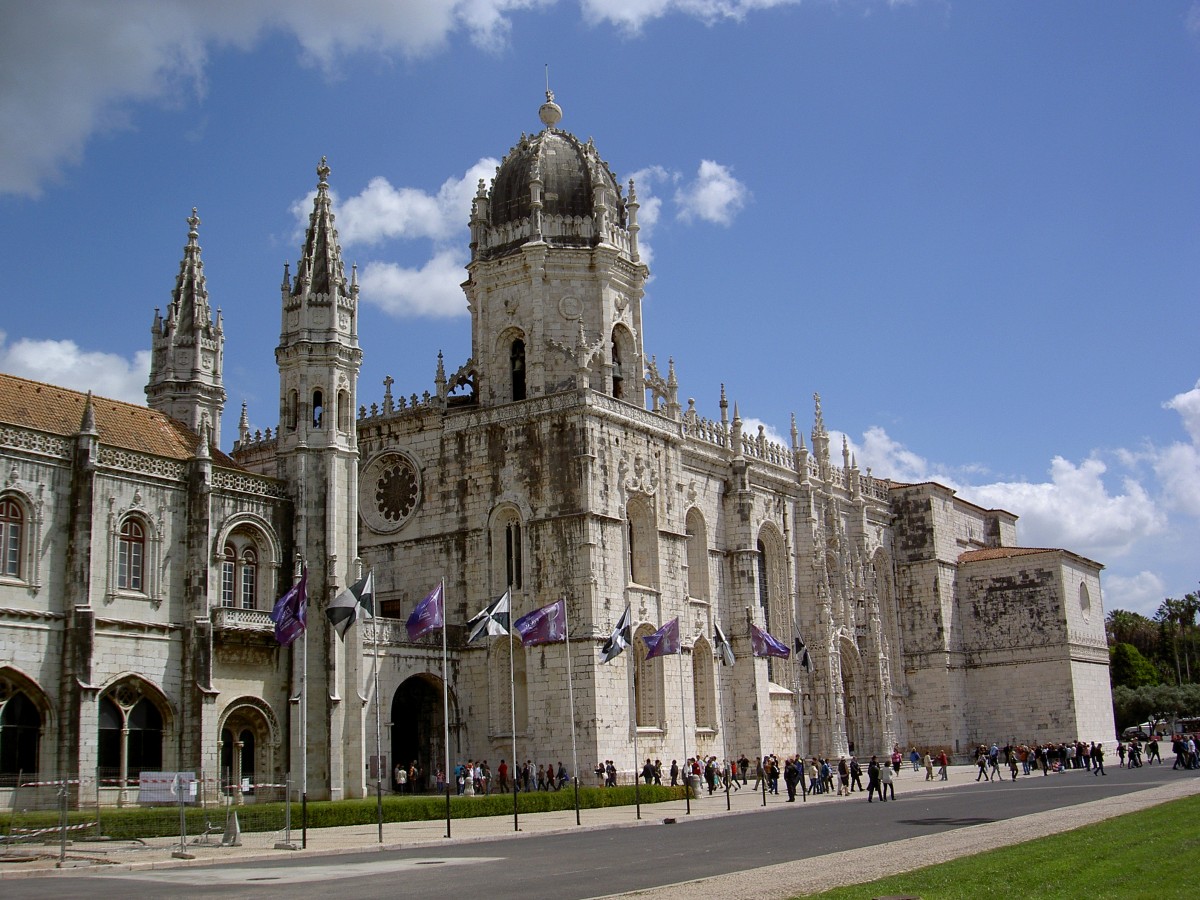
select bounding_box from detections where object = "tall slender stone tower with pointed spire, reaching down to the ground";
[275,158,362,798]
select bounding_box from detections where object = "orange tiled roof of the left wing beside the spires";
[0,373,241,469]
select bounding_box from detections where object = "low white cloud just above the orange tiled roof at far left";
[0,331,150,406]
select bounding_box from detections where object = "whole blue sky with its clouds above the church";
[0,0,1200,614]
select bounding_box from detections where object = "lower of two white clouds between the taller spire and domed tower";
[359,250,467,318]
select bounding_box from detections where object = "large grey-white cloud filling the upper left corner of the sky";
[0,0,530,196]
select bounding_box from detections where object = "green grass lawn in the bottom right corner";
[811,797,1200,900]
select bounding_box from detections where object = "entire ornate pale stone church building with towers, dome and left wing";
[0,96,1114,802]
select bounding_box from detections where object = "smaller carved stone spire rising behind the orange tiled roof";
[146,206,226,444]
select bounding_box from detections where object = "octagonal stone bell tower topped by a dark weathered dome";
[463,90,649,407]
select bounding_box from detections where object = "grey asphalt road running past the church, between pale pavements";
[7,767,1194,900]
